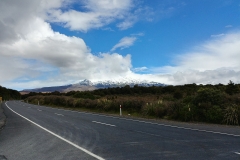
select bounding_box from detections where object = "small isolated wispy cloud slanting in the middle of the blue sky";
[111,37,137,51]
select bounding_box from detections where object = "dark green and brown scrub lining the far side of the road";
[22,81,240,125]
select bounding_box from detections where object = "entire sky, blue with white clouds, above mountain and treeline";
[0,0,240,90]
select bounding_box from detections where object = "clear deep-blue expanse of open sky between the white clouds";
[52,0,240,67]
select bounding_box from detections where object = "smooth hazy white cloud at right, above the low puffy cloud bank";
[178,32,240,71]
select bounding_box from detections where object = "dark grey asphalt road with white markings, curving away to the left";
[0,101,240,160]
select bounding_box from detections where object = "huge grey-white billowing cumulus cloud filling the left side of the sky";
[0,0,132,88]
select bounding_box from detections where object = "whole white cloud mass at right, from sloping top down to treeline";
[152,32,240,84]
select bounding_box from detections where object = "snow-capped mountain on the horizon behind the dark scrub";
[22,79,165,92]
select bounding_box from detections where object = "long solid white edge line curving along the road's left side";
[5,102,104,160]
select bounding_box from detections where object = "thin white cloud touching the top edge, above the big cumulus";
[46,0,136,32]
